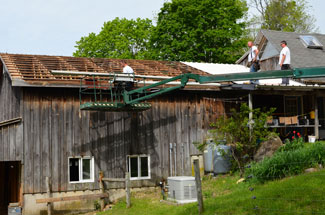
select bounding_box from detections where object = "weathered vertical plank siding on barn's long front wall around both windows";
[23,88,224,193]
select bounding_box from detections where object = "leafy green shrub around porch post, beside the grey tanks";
[211,103,275,176]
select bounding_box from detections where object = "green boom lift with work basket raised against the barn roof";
[52,67,325,111]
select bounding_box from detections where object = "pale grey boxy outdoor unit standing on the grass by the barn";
[167,176,197,204]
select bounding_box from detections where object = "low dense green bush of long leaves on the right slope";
[246,142,325,182]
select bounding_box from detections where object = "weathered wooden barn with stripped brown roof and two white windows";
[0,54,225,214]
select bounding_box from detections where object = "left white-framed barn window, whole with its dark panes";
[69,157,94,183]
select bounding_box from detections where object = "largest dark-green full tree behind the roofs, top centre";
[151,0,247,63]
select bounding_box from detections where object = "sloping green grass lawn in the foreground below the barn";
[98,170,325,215]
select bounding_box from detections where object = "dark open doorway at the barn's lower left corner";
[0,161,21,215]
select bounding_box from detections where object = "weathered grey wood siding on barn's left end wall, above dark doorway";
[0,64,23,161]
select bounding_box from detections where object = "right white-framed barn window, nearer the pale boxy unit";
[128,155,150,180]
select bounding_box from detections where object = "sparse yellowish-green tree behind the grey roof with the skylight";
[251,0,318,33]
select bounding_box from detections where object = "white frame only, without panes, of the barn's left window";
[68,156,95,184]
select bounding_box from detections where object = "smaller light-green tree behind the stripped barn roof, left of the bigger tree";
[73,18,152,59]
